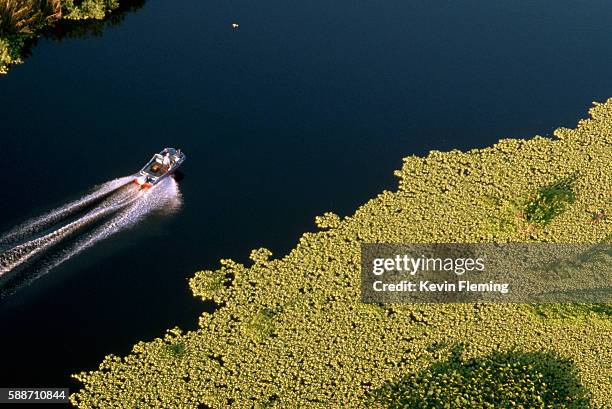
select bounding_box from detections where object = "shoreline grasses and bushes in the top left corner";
[0,0,144,75]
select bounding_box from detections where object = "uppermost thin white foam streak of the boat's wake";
[0,176,134,244]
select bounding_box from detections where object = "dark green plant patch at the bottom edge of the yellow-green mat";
[369,346,590,409]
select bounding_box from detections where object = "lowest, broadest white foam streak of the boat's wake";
[39,178,183,276]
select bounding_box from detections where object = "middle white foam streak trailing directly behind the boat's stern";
[0,186,142,277]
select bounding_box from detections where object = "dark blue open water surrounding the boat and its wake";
[0,0,612,392]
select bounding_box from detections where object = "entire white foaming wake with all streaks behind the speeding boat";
[0,176,182,298]
